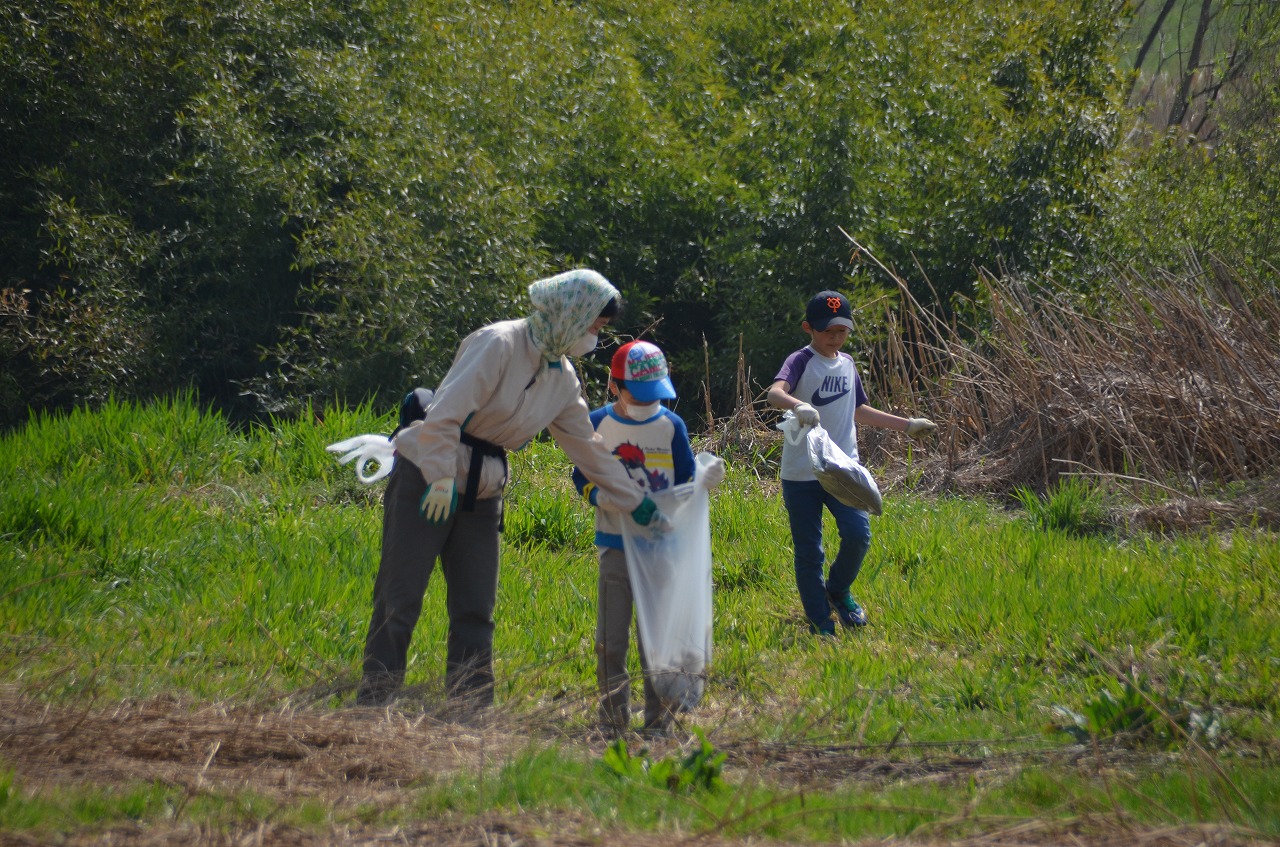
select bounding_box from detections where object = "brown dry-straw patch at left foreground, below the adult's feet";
[0,700,509,805]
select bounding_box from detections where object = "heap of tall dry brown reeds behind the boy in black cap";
[849,249,1280,526]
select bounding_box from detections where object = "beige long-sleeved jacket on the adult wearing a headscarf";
[396,319,644,512]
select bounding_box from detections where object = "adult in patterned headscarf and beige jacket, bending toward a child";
[356,270,664,706]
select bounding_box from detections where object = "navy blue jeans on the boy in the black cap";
[782,480,872,629]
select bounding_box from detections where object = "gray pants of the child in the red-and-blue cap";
[595,548,671,732]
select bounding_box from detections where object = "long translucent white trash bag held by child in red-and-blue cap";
[622,453,716,711]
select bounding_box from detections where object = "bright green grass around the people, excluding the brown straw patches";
[0,398,1280,841]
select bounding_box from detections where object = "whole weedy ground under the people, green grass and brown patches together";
[0,398,1280,844]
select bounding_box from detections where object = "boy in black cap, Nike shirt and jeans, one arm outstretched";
[768,292,937,636]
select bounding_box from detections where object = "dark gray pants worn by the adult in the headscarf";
[356,458,502,706]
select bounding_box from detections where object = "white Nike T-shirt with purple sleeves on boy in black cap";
[773,347,867,481]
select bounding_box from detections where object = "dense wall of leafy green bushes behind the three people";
[0,0,1141,425]
